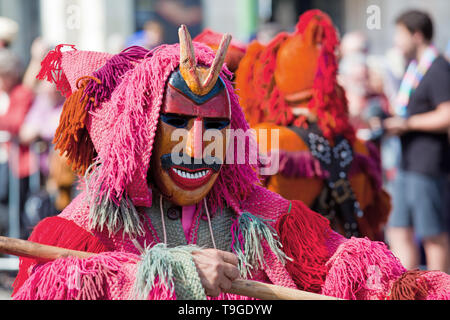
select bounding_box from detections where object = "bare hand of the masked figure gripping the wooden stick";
[192,249,239,297]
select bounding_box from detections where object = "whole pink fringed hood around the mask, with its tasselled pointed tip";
[38,42,257,233]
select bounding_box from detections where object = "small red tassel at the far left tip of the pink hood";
[36,44,76,98]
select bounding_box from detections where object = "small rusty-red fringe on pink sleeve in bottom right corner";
[389,270,428,300]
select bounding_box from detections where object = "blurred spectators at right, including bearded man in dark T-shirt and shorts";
[339,10,450,272]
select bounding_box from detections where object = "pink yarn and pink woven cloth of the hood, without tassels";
[55,43,257,212]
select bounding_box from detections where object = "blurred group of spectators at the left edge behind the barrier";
[0,17,75,238]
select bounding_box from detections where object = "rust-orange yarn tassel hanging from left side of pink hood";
[53,76,100,175]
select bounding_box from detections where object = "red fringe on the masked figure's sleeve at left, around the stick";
[12,216,108,295]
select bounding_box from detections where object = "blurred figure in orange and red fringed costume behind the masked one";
[236,10,390,240]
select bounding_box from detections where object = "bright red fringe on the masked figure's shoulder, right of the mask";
[276,200,331,292]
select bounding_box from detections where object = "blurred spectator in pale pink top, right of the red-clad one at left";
[19,38,75,226]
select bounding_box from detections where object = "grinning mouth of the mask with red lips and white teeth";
[161,154,222,190]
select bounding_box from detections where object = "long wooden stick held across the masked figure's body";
[0,237,340,300]
